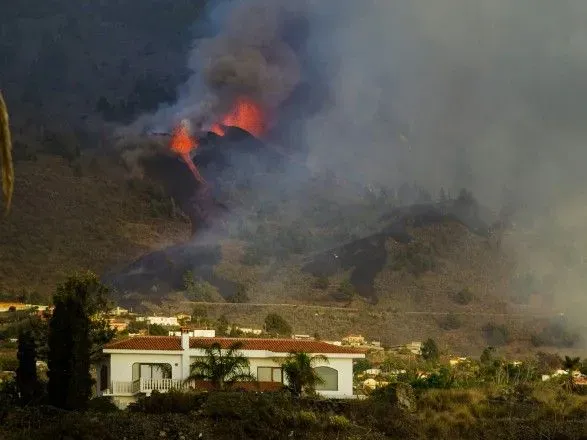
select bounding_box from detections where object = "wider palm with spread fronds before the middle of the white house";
[185,342,256,390]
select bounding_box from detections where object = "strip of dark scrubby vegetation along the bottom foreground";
[0,384,587,440]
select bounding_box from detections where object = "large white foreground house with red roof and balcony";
[96,332,365,407]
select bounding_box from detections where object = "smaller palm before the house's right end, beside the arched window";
[281,353,328,397]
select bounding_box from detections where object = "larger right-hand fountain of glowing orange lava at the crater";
[210,96,267,138]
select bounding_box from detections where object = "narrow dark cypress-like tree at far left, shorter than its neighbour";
[16,328,39,405]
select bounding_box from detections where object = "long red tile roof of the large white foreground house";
[104,336,365,353]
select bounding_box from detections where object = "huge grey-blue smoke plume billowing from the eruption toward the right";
[136,0,587,322]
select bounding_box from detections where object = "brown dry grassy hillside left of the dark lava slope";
[0,155,189,294]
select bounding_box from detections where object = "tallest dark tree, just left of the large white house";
[47,272,110,409]
